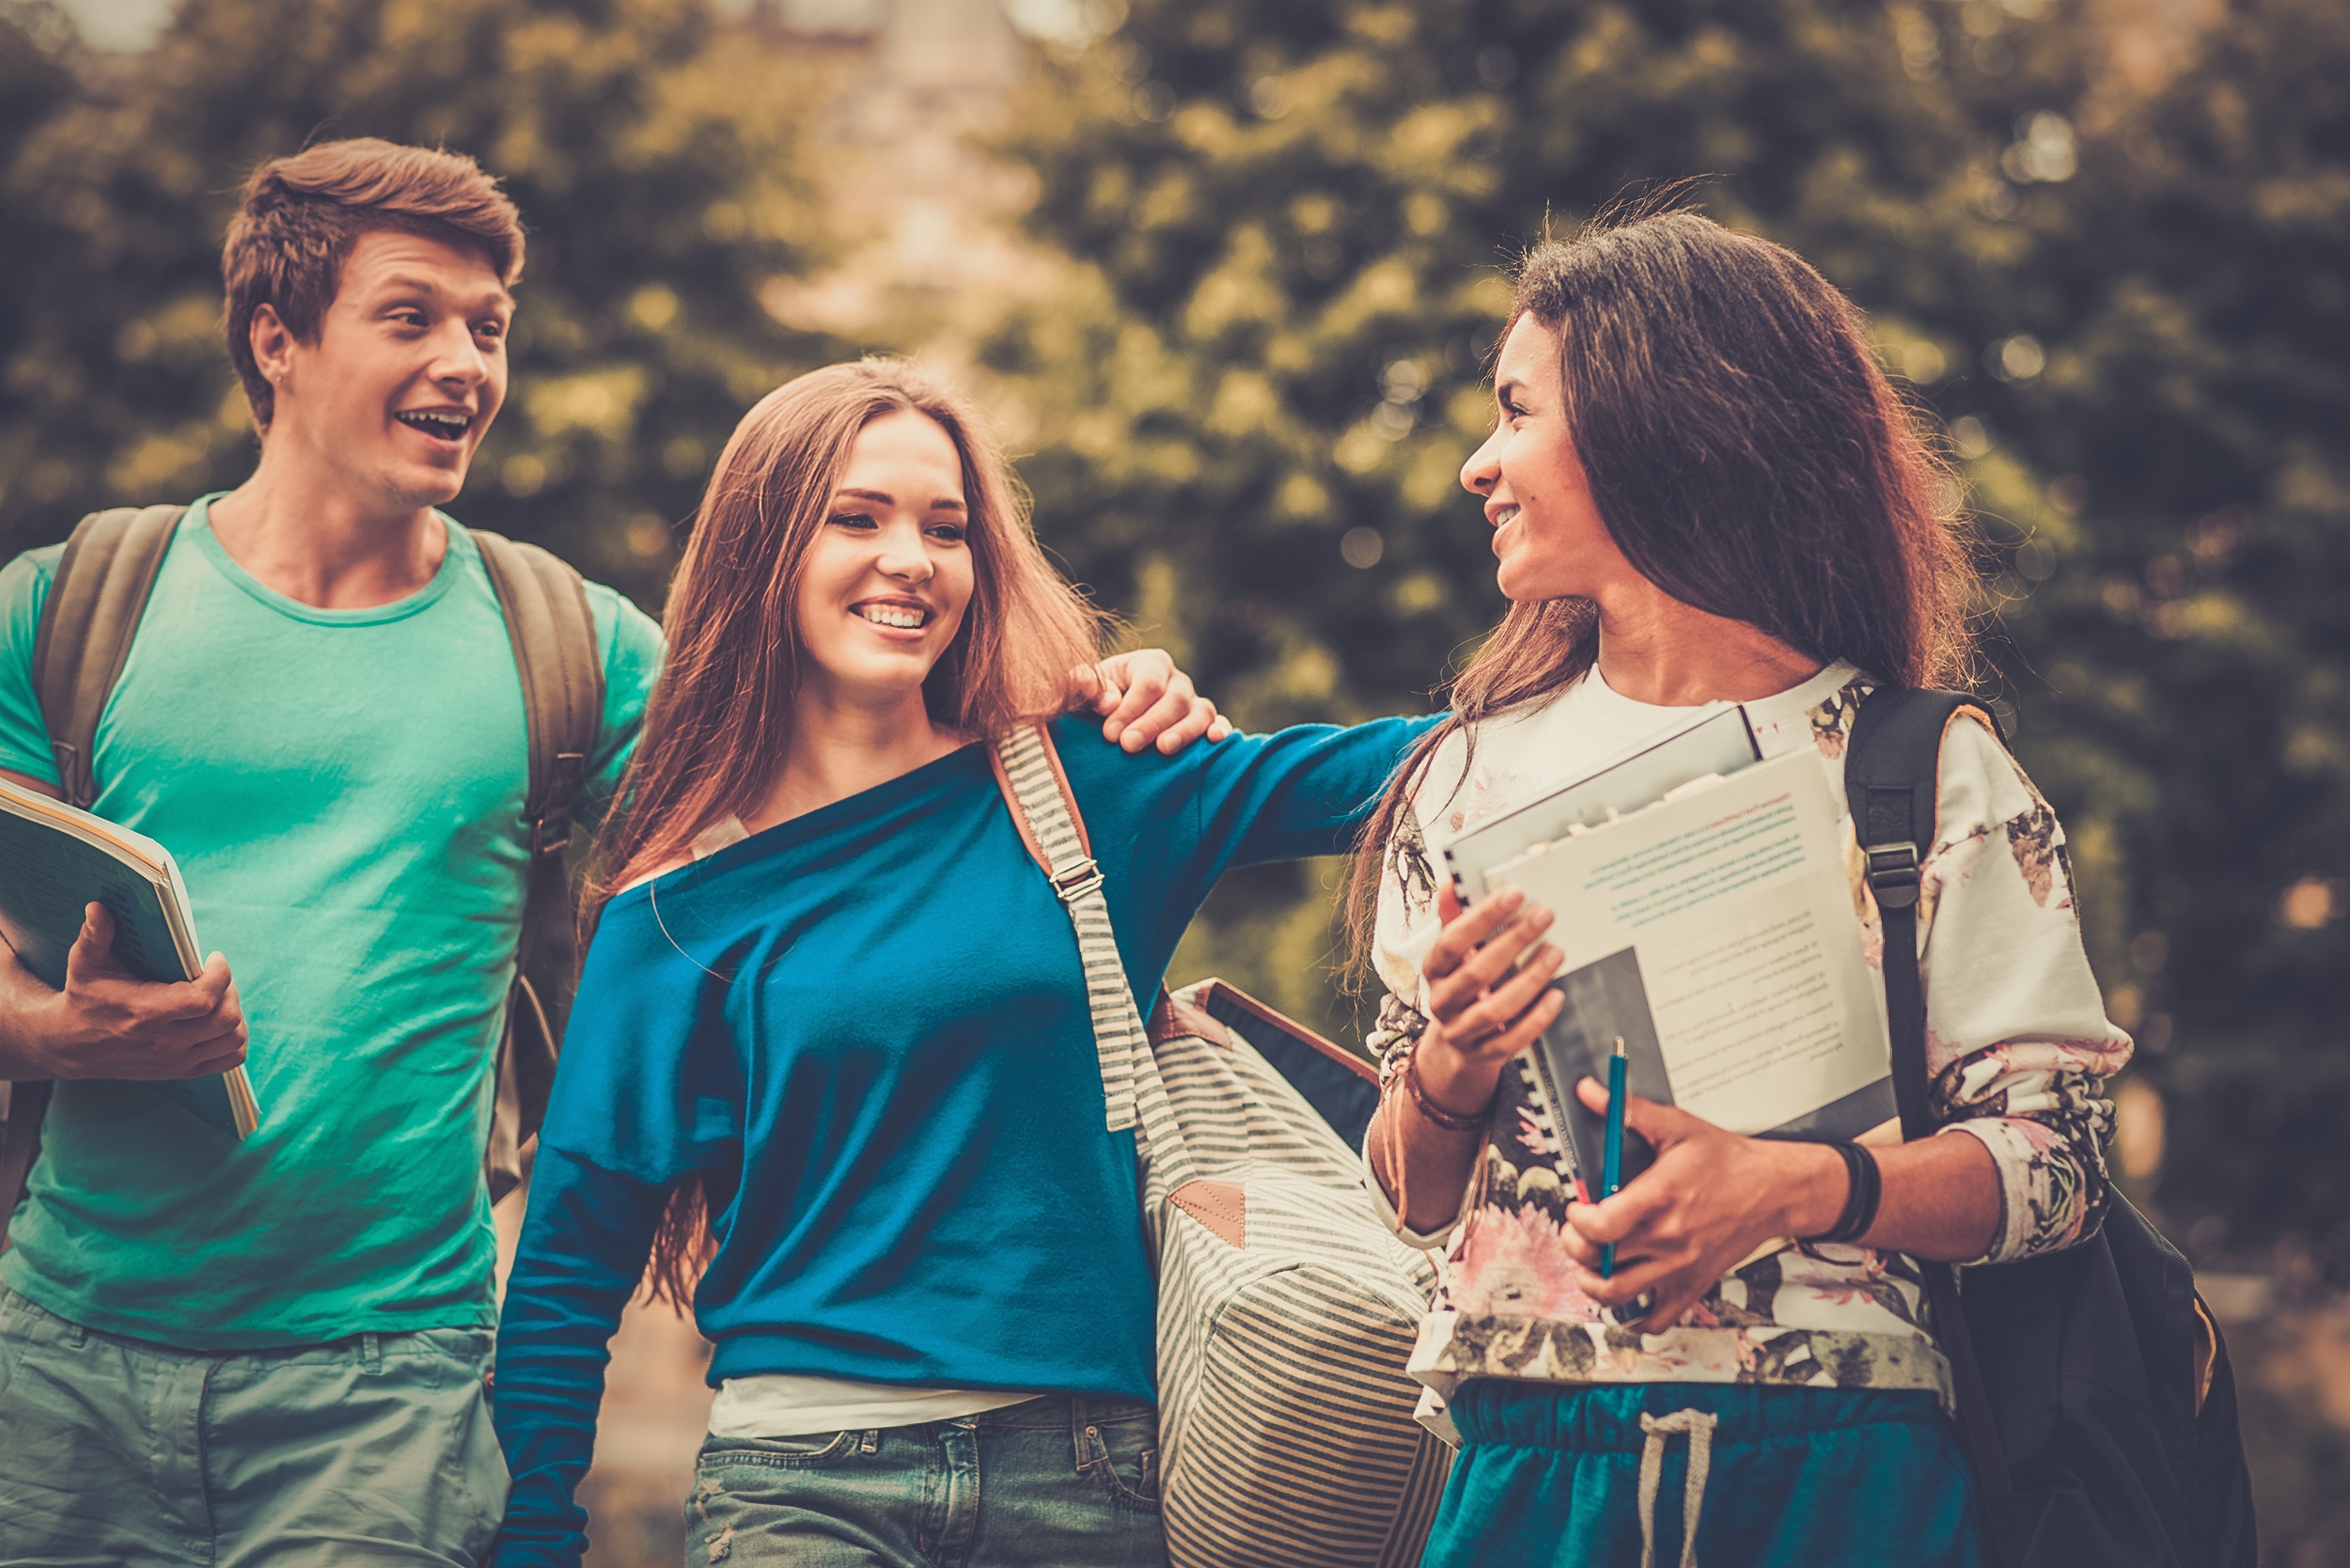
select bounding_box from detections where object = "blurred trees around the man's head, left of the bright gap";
[0,0,835,604]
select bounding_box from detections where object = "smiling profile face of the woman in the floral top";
[1462,315,1638,602]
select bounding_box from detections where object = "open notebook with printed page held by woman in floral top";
[1485,747,1897,1197]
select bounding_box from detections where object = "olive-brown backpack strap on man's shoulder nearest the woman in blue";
[473,529,604,1201]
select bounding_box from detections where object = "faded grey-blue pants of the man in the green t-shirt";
[0,1286,506,1568]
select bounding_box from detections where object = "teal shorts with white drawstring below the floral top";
[1422,1377,1986,1568]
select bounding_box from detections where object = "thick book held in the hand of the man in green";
[0,778,261,1137]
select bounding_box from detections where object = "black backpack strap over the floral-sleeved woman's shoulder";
[1845,686,2014,1546]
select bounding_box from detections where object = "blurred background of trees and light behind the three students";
[0,0,2350,1568]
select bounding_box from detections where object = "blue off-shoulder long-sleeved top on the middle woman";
[496,719,1427,1568]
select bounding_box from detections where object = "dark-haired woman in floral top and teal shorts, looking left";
[1354,212,2129,1568]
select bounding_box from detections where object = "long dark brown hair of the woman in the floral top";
[1347,212,1972,982]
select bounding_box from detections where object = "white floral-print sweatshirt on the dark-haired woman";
[1372,666,2132,1401]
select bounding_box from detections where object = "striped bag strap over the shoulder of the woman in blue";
[992,724,1152,1133]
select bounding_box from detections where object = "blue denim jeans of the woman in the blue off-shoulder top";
[686,1396,1168,1568]
